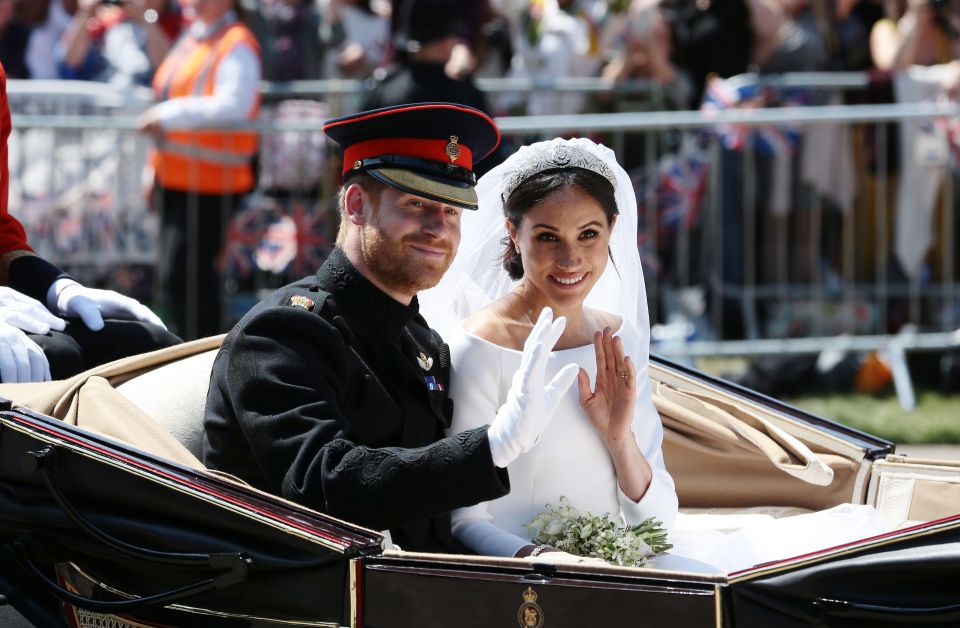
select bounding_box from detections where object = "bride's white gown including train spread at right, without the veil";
[449,324,893,573]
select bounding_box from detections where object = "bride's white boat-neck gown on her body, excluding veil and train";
[448,323,677,556]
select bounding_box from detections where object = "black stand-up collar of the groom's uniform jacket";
[317,247,420,336]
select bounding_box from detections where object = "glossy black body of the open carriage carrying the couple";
[0,354,960,628]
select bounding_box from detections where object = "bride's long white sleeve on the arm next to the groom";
[448,328,530,556]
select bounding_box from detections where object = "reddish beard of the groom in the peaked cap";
[360,219,453,293]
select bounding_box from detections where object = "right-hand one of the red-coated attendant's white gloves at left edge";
[48,279,167,331]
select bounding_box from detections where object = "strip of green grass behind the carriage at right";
[698,358,960,444]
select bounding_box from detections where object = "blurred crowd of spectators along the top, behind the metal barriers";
[0,0,960,105]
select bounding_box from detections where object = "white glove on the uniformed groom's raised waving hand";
[487,307,579,467]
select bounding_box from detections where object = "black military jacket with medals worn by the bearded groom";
[204,249,509,551]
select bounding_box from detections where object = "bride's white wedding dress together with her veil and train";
[418,138,893,573]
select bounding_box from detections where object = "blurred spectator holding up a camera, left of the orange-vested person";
[58,0,182,86]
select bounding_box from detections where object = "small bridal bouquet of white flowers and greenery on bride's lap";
[526,497,673,567]
